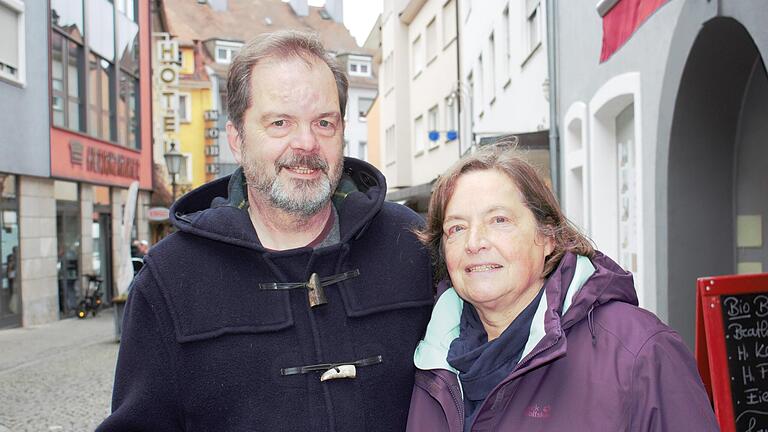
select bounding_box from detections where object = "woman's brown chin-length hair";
[416,142,595,280]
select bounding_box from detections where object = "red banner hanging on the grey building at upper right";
[600,0,669,63]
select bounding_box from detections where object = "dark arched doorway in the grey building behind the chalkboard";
[667,18,768,346]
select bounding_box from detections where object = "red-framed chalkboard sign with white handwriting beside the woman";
[696,273,768,432]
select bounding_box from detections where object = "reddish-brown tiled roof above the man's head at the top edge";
[161,0,367,54]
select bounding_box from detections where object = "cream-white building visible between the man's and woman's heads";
[379,0,461,210]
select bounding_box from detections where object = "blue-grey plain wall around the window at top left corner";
[0,0,50,177]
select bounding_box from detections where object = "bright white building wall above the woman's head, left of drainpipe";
[461,0,549,139]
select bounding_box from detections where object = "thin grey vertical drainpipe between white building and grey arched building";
[547,0,562,202]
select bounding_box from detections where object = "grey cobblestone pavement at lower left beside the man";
[0,310,119,432]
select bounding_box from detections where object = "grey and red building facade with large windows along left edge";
[0,0,152,326]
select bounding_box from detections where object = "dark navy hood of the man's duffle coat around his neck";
[170,158,387,251]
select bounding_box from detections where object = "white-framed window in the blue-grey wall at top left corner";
[0,0,25,84]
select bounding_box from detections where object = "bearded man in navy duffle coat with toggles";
[99,32,432,431]
